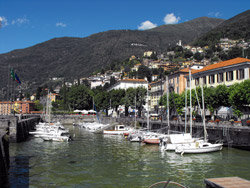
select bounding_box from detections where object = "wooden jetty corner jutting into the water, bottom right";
[204,177,250,188]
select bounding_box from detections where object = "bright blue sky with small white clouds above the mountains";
[0,0,250,54]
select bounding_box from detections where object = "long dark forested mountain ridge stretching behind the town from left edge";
[0,17,224,93]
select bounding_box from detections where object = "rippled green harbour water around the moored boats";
[10,126,250,188]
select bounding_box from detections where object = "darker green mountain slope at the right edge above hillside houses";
[194,10,250,46]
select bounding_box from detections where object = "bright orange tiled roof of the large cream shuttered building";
[192,57,250,74]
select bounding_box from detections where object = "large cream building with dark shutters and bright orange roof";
[191,57,250,87]
